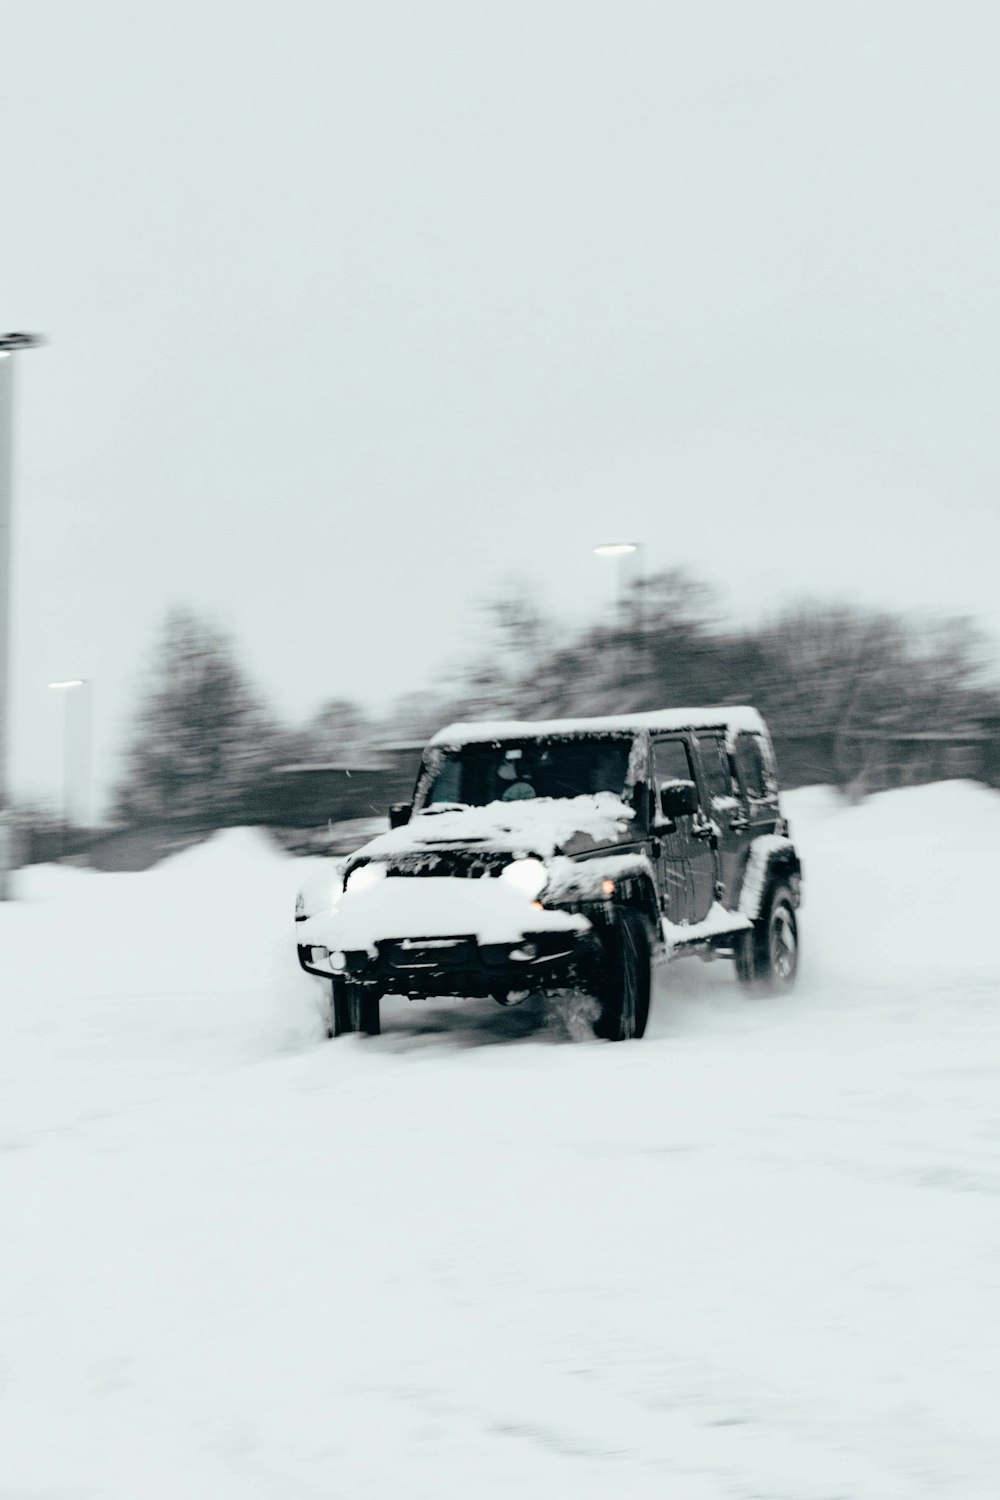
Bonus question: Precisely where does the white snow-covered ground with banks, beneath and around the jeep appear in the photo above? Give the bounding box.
[0,783,1000,1500]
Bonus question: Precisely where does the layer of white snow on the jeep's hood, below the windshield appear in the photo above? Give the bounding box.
[358,792,634,860]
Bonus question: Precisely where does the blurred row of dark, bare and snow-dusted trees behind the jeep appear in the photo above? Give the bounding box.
[29,570,1000,827]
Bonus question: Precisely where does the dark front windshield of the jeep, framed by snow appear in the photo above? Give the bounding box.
[414,735,631,812]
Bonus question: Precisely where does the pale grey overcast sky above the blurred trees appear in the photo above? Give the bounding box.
[0,0,1000,822]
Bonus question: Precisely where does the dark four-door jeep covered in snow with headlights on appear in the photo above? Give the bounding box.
[295,707,802,1041]
